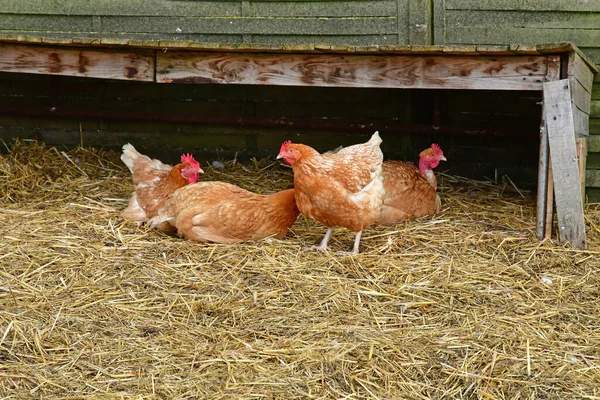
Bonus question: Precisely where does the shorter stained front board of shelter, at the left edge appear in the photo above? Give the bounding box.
[0,44,154,81]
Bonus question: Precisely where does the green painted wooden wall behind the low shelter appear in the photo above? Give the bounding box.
[0,0,600,201]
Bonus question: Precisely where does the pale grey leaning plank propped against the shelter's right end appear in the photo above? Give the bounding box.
[543,79,586,248]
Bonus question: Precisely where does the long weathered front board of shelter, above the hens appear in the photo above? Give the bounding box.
[156,51,547,90]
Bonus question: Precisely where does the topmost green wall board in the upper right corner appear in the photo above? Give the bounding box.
[446,0,600,12]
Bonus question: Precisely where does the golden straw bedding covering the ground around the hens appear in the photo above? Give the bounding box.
[0,139,600,399]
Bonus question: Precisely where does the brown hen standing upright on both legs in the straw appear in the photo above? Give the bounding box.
[277,132,384,254]
